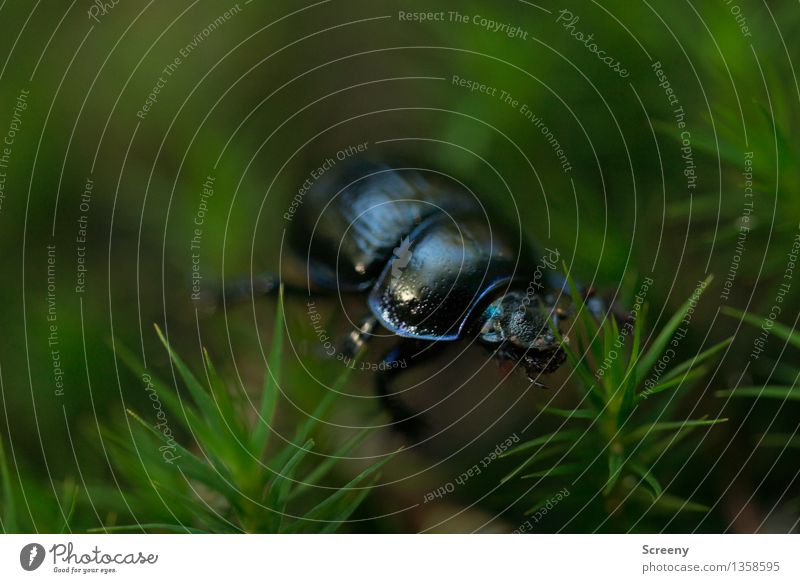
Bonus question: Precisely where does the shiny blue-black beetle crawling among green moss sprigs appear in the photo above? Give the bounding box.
[223,159,580,436]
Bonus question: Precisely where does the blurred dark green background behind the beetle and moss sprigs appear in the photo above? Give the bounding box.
[0,0,800,532]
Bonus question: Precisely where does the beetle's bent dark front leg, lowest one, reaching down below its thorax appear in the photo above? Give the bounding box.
[376,340,442,441]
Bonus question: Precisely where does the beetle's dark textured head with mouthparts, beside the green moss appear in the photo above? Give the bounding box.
[479,291,566,382]
